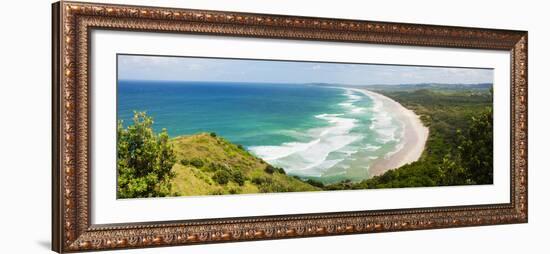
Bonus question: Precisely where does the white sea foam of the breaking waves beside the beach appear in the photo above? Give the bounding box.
[253,88,402,177]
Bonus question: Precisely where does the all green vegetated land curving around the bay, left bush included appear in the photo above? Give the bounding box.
[117,84,493,198]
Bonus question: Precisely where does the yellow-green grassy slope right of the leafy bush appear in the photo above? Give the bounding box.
[170,133,319,196]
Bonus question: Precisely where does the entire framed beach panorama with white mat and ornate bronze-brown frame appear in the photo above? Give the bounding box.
[52,2,527,252]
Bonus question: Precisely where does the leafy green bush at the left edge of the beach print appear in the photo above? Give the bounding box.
[117,112,176,198]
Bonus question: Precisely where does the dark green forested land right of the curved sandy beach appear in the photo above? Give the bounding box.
[324,87,493,190]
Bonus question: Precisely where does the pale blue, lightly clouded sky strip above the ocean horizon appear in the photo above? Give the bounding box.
[118,55,493,85]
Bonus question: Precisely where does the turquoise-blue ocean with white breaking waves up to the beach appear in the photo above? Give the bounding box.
[117,80,403,183]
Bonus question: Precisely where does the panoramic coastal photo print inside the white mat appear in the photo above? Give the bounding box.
[116,54,494,198]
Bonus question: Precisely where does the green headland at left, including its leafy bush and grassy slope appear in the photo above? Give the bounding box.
[117,112,321,198]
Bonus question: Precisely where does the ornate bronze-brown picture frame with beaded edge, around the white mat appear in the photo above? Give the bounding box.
[52,2,527,252]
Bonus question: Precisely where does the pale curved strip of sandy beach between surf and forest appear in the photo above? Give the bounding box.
[353,89,429,177]
